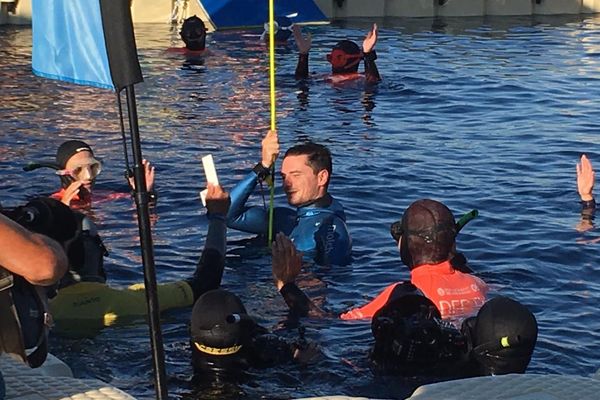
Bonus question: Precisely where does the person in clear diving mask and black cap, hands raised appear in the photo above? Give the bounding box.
[50,140,156,208]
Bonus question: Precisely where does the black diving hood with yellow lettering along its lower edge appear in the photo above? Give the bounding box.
[190,289,249,356]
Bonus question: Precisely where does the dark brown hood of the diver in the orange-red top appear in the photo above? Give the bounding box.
[400,199,456,269]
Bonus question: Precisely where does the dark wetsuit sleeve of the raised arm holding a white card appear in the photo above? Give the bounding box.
[188,215,227,299]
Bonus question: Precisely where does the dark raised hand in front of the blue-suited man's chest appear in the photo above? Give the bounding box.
[272,233,302,290]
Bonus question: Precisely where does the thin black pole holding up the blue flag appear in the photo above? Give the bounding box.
[125,85,168,400]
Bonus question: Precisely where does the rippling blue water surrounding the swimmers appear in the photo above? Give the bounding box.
[0,16,600,398]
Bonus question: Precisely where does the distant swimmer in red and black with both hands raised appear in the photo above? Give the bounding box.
[292,24,381,83]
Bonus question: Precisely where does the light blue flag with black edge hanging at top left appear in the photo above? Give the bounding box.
[32,0,143,91]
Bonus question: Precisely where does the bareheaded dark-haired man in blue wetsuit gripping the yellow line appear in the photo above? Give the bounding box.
[227,131,352,265]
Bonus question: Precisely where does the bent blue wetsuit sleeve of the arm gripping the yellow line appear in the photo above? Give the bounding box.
[227,171,268,234]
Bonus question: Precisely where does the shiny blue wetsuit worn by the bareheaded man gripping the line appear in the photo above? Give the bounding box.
[227,172,352,265]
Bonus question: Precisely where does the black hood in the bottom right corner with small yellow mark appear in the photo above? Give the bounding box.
[472,296,538,375]
